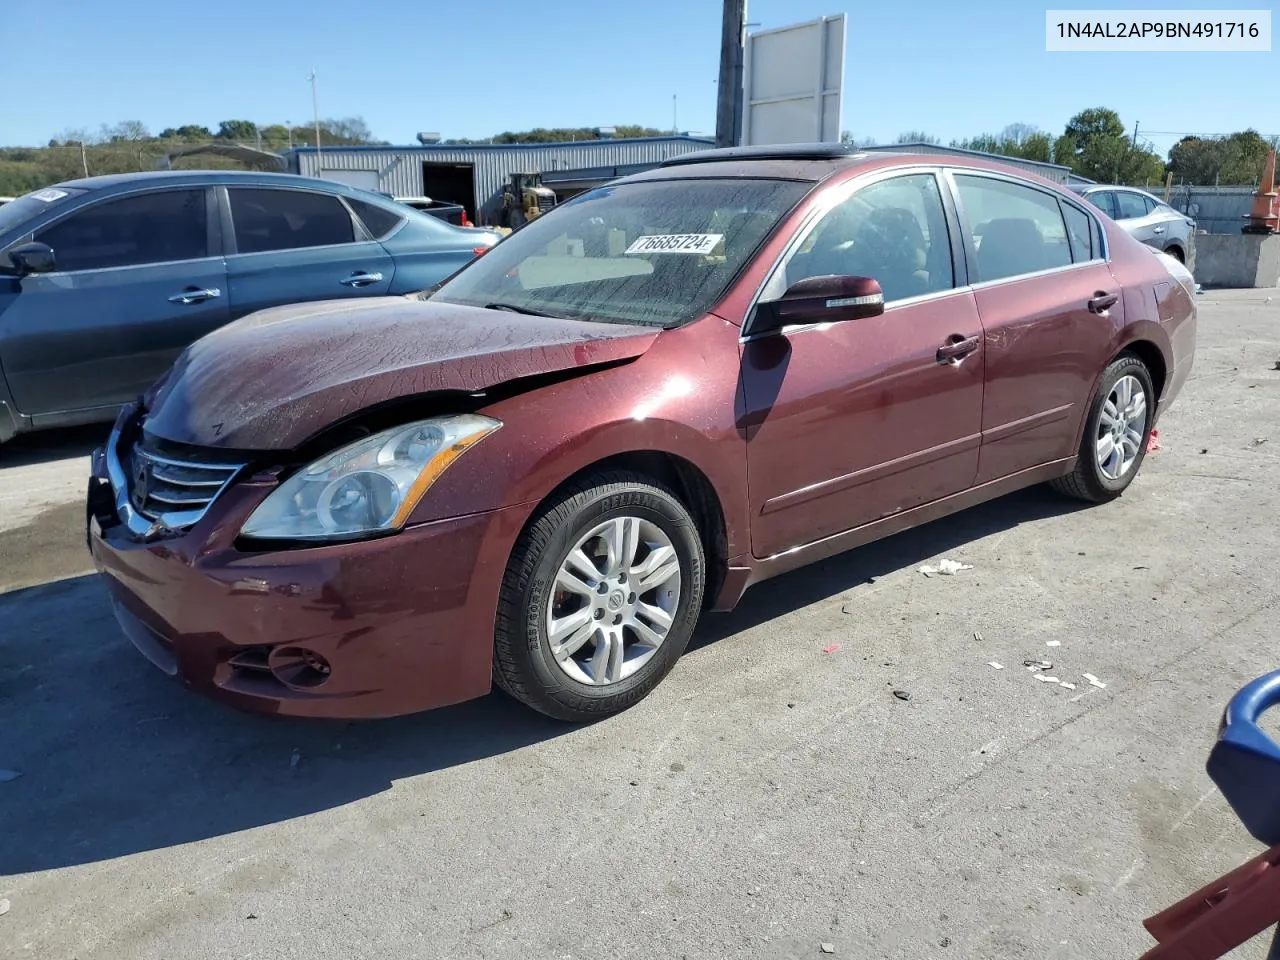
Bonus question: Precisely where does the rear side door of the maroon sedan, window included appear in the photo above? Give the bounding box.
[948,172,1123,483]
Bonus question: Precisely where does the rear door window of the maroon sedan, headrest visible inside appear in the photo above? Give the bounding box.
[955,174,1071,282]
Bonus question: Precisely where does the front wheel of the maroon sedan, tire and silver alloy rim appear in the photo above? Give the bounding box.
[493,471,705,722]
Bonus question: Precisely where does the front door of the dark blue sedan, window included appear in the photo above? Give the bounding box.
[0,187,229,416]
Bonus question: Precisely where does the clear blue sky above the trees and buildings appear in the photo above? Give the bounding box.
[0,0,1280,158]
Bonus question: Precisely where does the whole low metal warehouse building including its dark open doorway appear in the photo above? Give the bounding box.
[284,136,714,223]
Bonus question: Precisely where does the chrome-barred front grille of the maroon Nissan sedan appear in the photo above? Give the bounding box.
[125,440,243,530]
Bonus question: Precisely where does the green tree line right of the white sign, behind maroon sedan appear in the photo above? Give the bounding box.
[844,106,1277,187]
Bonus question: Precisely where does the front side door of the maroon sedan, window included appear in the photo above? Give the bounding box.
[741,172,983,557]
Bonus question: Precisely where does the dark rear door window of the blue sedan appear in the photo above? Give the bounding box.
[228,187,356,253]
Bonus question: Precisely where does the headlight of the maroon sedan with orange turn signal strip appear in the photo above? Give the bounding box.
[241,413,502,540]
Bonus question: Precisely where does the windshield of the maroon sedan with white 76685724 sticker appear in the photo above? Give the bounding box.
[431,179,812,326]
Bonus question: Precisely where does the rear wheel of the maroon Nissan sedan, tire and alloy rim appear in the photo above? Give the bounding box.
[1050,353,1156,503]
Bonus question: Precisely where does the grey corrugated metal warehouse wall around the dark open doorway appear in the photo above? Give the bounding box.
[288,137,714,224]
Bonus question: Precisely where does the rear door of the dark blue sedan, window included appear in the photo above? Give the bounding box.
[227,180,396,317]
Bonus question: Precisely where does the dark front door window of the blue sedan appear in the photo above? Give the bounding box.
[35,188,209,271]
